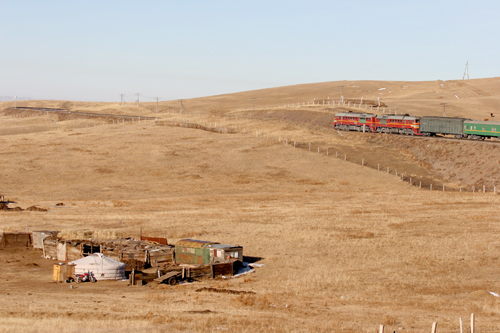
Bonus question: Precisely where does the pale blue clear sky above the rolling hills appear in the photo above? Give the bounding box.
[0,0,500,102]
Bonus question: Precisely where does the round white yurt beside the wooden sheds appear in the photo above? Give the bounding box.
[71,253,126,281]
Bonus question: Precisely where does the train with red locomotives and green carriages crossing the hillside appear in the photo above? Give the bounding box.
[333,111,500,140]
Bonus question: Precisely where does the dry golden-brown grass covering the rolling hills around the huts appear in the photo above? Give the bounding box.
[0,78,500,333]
